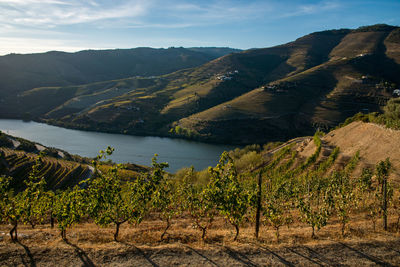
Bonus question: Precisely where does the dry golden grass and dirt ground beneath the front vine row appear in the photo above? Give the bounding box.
[0,220,400,267]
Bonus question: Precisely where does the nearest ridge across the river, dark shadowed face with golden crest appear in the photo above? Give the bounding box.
[178,26,400,142]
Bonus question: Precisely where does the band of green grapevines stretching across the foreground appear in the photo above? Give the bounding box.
[0,133,400,241]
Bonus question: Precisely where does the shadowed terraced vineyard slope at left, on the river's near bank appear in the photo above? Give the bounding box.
[0,132,147,191]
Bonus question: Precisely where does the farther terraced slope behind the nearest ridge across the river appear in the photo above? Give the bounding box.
[21,30,347,128]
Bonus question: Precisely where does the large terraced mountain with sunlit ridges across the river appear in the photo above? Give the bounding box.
[0,25,400,144]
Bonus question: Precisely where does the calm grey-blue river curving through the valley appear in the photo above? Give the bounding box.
[0,119,234,172]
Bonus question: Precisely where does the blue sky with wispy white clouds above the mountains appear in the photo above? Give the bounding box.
[0,0,400,55]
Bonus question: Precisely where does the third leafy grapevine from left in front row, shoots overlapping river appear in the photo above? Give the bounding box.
[87,147,168,241]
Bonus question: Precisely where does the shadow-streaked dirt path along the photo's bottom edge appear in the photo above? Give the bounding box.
[0,240,400,267]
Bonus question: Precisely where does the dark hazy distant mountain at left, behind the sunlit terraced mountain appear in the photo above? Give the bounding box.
[0,47,240,100]
